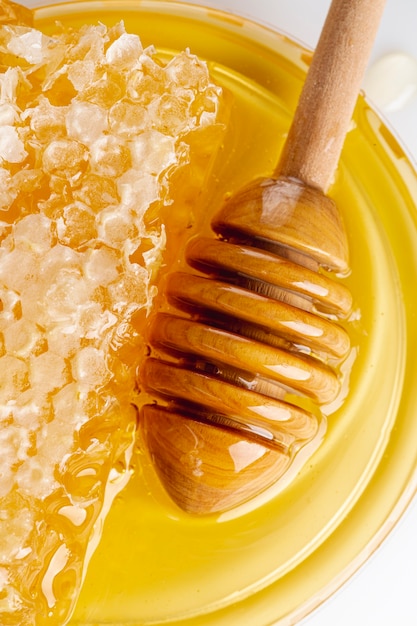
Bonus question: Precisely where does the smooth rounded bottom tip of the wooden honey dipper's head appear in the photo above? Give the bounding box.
[143,405,290,514]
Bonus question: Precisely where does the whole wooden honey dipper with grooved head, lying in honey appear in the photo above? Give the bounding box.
[139,0,385,514]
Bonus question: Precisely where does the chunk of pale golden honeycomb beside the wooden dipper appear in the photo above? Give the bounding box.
[0,2,222,626]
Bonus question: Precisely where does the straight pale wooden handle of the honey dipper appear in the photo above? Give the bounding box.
[277,0,385,192]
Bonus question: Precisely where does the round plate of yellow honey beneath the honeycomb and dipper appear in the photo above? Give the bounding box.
[35,0,417,626]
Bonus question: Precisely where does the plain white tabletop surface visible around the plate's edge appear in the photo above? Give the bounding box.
[22,0,417,626]
